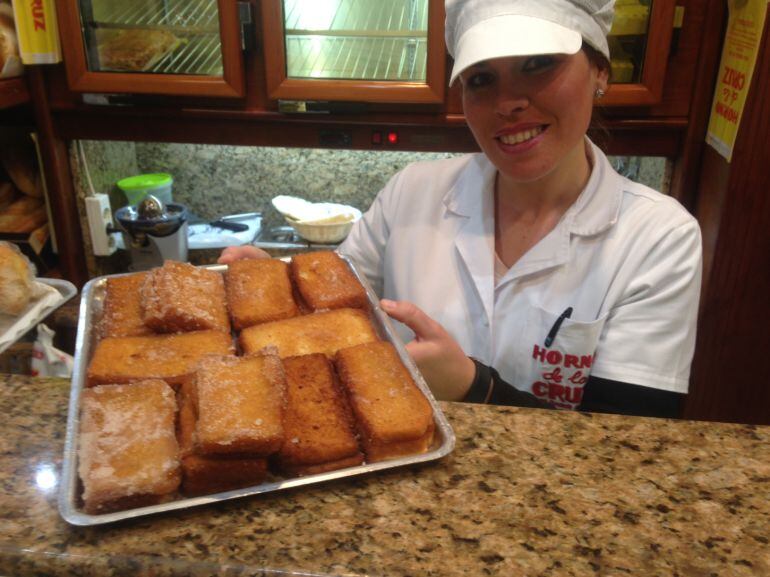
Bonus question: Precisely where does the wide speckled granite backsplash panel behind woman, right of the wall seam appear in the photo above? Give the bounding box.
[130,143,668,226]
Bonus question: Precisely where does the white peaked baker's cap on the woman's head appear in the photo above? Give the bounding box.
[446,0,615,84]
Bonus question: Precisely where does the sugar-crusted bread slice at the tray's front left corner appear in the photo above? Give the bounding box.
[78,379,181,514]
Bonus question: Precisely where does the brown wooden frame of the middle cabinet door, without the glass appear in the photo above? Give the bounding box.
[261,0,447,104]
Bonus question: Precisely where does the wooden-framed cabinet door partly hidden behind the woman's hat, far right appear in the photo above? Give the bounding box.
[602,0,675,106]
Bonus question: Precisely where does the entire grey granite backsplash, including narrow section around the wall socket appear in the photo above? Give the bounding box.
[70,141,671,276]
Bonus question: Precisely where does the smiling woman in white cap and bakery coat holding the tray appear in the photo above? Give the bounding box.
[221,0,701,416]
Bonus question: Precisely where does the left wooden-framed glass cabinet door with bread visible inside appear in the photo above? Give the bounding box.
[57,0,244,97]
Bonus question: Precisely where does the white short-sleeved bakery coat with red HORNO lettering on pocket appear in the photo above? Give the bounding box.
[340,141,702,408]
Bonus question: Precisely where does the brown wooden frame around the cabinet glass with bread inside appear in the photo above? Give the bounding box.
[56,0,245,98]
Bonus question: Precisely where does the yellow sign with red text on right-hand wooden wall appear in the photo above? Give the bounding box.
[706,0,768,162]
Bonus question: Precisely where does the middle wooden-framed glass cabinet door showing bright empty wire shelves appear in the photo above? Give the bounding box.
[262,0,446,103]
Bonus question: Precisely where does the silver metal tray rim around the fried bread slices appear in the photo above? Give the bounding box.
[59,255,455,526]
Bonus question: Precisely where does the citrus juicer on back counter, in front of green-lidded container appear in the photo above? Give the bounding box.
[115,195,188,271]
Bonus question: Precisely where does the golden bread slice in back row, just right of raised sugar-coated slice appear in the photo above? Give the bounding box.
[225,258,300,330]
